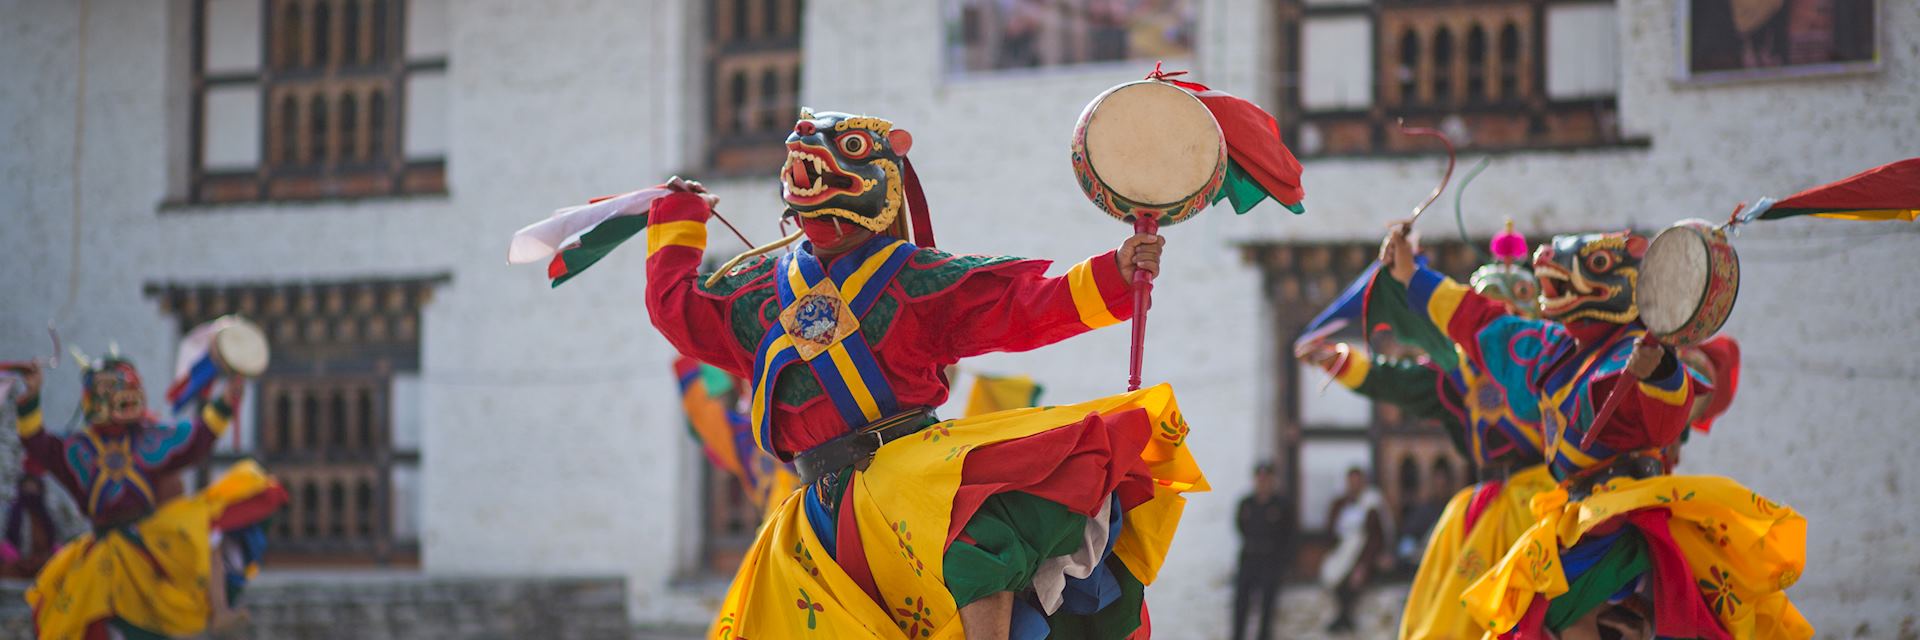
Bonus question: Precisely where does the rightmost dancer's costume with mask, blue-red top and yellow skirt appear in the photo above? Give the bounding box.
[1407,234,1812,638]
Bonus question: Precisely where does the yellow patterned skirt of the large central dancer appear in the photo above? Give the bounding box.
[708,384,1208,640]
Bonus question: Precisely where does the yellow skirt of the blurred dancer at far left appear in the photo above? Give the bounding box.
[27,461,275,640]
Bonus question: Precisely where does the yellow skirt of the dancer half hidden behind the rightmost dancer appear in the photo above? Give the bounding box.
[1400,465,1555,640]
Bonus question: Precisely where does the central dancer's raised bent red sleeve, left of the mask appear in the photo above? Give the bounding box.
[647,194,753,377]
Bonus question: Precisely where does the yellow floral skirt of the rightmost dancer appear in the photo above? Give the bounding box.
[1461,475,1812,640]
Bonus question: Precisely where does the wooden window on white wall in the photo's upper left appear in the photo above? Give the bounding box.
[186,0,447,202]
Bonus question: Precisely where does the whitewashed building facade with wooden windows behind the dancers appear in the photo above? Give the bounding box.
[0,0,1920,636]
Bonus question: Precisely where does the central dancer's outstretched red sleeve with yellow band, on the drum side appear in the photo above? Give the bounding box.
[916,252,1133,359]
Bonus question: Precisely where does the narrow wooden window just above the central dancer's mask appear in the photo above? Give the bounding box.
[707,0,801,175]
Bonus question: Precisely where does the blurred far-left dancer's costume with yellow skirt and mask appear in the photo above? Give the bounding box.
[17,359,286,640]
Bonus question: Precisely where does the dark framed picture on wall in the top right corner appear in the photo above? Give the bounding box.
[1678,0,1880,83]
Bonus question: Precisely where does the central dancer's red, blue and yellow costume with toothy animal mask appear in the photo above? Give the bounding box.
[647,107,1206,640]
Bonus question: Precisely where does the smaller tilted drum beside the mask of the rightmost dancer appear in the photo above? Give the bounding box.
[1634,219,1740,346]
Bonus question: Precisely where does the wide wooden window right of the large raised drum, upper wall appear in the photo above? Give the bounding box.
[1275,0,1644,156]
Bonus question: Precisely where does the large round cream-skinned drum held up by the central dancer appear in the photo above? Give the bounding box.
[1073,81,1227,225]
